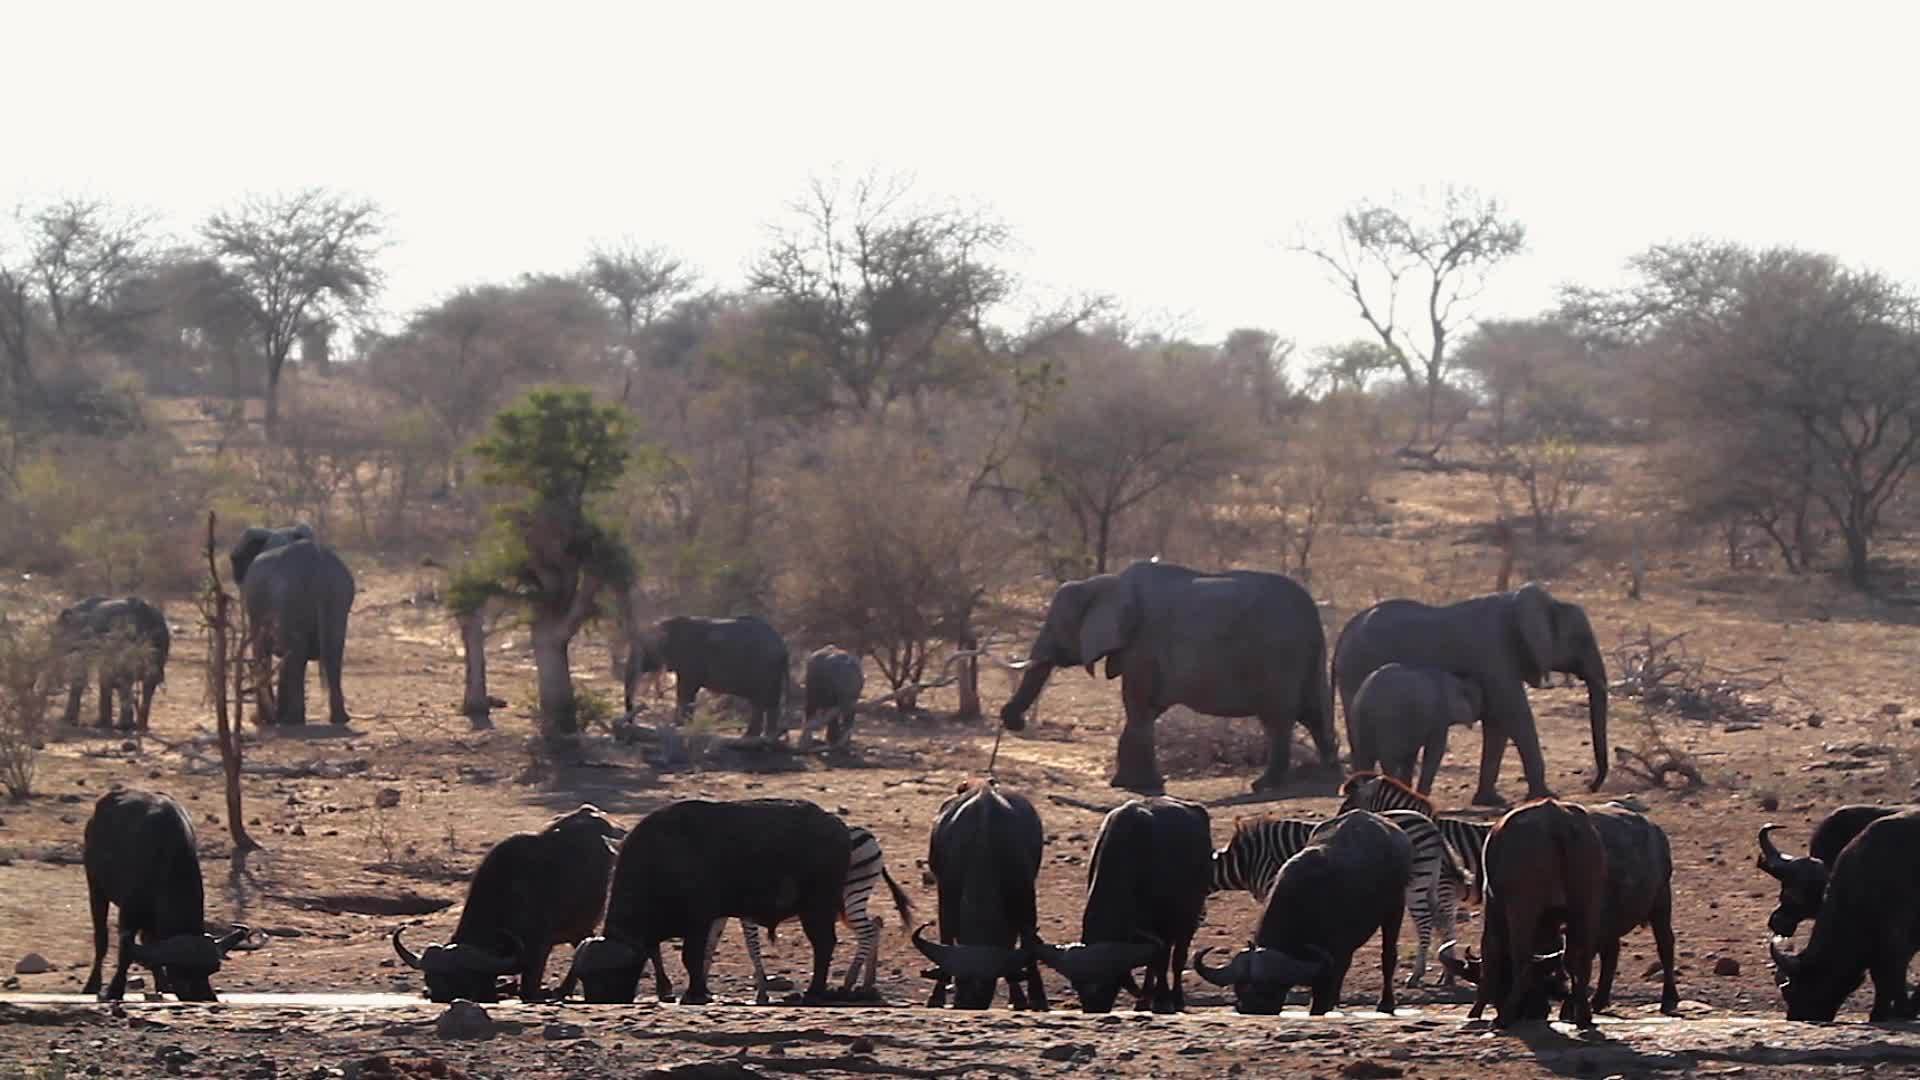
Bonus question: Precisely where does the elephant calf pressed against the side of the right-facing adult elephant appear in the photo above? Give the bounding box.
[1346,663,1486,796]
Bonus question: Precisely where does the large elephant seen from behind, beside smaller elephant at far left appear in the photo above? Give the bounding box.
[228,525,353,724]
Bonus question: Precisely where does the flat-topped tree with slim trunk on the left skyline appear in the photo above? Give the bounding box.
[200,188,380,440]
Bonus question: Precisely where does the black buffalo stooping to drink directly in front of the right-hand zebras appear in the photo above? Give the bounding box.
[1194,811,1413,1015]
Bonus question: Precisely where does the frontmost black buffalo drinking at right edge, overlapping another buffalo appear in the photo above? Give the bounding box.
[1768,809,1920,1020]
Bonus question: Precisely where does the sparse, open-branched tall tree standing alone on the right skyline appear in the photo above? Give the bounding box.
[1294,186,1526,442]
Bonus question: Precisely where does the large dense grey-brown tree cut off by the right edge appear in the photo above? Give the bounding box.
[1567,244,1920,588]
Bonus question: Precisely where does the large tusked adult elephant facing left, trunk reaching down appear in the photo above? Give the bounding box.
[1000,561,1336,794]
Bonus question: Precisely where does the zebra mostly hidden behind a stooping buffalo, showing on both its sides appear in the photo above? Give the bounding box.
[1212,807,1459,986]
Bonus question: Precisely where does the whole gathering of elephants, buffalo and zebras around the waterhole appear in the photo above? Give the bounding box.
[45,527,1920,1026]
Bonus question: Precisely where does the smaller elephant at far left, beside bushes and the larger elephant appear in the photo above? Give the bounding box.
[56,596,173,730]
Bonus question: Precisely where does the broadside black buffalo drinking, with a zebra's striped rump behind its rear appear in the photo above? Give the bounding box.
[561,799,852,1005]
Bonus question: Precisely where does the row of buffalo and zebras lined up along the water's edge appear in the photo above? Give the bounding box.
[84,773,1920,1026]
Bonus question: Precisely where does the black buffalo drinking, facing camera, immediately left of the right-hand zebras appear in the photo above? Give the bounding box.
[1039,798,1213,1013]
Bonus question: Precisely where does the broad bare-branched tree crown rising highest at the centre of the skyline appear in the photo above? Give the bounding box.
[747,179,1012,413]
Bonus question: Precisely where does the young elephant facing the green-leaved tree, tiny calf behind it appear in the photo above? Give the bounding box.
[626,615,787,738]
